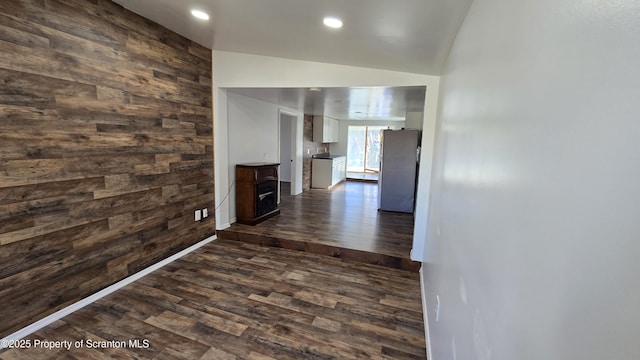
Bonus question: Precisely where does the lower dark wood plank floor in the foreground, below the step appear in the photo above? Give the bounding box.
[0,239,425,360]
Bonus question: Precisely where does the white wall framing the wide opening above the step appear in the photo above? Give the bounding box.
[213,50,440,260]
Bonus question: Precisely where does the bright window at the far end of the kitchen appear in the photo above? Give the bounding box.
[347,126,389,173]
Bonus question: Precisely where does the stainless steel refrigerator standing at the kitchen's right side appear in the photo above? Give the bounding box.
[378,130,420,213]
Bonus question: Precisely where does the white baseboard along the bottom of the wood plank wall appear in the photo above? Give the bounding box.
[0,235,217,350]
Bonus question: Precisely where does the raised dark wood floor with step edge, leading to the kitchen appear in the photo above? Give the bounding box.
[218,181,420,271]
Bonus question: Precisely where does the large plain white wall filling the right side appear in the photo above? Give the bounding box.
[423,0,640,360]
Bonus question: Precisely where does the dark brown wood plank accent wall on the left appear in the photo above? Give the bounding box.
[0,0,215,337]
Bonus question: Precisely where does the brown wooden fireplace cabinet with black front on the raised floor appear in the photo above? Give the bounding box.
[236,163,280,225]
